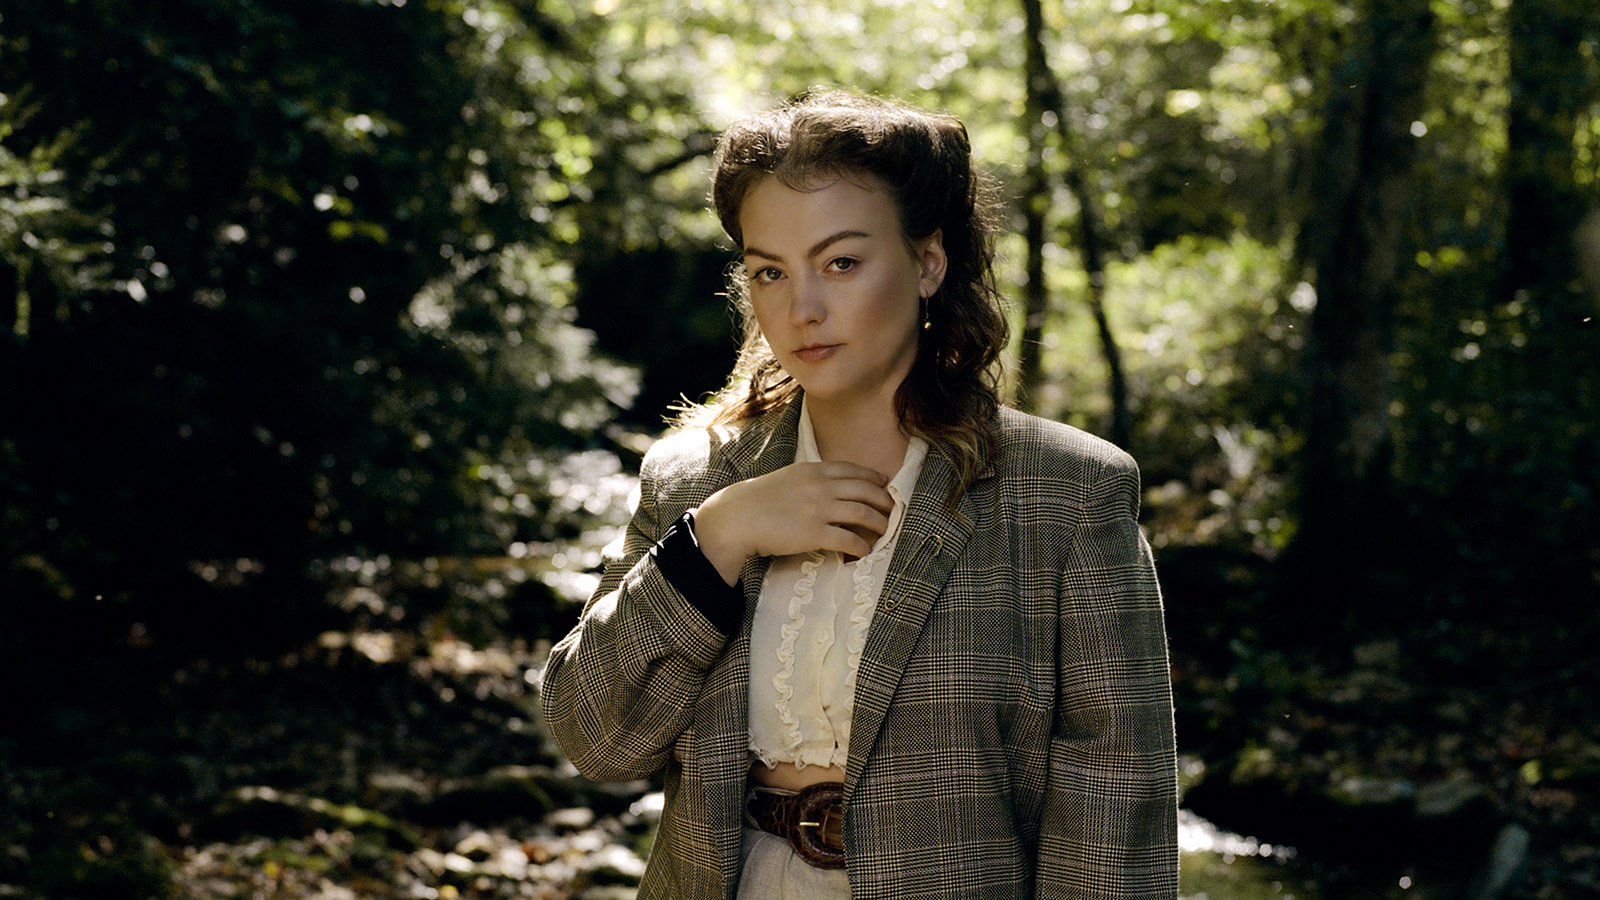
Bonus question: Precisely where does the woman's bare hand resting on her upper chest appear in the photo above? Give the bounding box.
[694,461,894,585]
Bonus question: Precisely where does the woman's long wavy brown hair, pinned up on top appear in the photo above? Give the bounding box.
[678,91,1008,501]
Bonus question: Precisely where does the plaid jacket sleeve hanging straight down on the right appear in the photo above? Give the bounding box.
[1035,452,1178,900]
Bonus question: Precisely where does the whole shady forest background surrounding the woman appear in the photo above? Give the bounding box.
[0,0,1600,897]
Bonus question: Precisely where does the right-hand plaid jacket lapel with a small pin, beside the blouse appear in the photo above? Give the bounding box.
[845,448,978,798]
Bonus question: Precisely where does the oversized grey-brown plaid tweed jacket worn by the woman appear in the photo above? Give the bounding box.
[541,402,1178,900]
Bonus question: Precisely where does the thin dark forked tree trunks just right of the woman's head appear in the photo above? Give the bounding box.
[1021,0,1133,447]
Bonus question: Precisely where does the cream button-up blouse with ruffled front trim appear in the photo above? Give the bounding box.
[750,400,928,769]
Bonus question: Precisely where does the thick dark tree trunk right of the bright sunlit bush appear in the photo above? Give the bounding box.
[1294,0,1435,609]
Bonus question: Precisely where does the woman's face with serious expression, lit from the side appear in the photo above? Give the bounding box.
[739,176,946,405]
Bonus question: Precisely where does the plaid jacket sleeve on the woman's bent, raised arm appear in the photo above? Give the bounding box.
[539,445,728,781]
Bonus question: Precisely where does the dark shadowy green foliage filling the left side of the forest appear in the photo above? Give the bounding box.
[0,0,652,646]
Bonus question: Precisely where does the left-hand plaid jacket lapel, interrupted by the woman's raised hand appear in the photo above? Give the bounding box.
[694,399,800,884]
